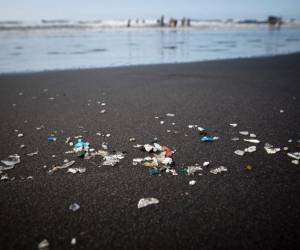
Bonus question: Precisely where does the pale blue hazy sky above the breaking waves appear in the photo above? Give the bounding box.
[0,0,300,20]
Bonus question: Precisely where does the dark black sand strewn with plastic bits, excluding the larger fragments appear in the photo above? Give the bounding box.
[0,54,300,249]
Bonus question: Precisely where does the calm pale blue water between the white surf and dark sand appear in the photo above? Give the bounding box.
[0,26,300,73]
